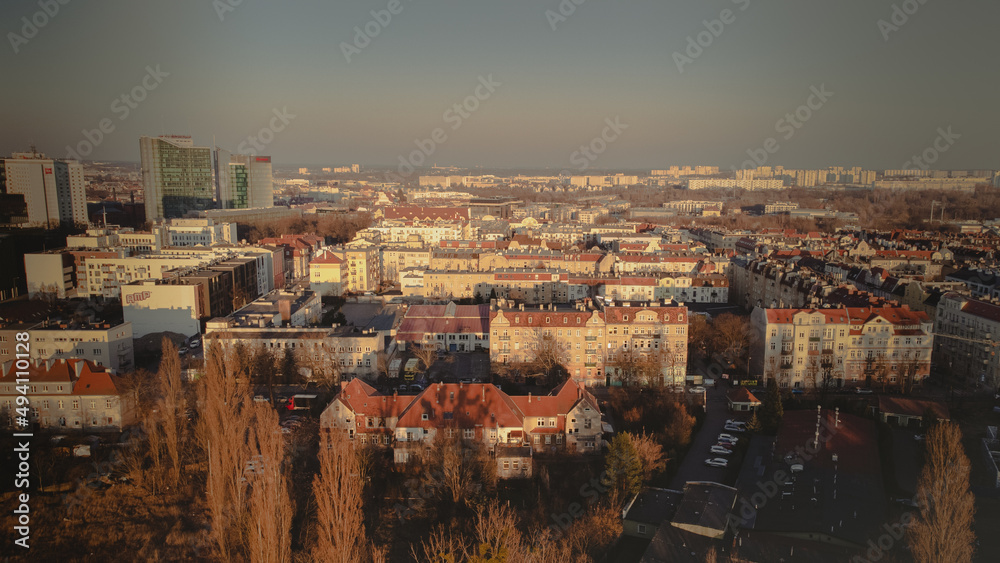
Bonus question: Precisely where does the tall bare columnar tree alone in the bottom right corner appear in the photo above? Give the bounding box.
[907,423,976,563]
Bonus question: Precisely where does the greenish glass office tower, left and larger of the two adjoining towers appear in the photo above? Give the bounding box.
[139,135,215,221]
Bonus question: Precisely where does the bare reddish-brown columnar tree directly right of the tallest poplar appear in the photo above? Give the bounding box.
[244,405,295,563]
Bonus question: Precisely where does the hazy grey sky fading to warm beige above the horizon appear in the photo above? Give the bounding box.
[0,0,1000,170]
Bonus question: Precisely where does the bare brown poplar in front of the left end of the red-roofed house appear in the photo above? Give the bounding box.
[312,430,365,563]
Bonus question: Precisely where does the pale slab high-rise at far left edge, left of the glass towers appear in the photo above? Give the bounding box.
[0,150,87,226]
